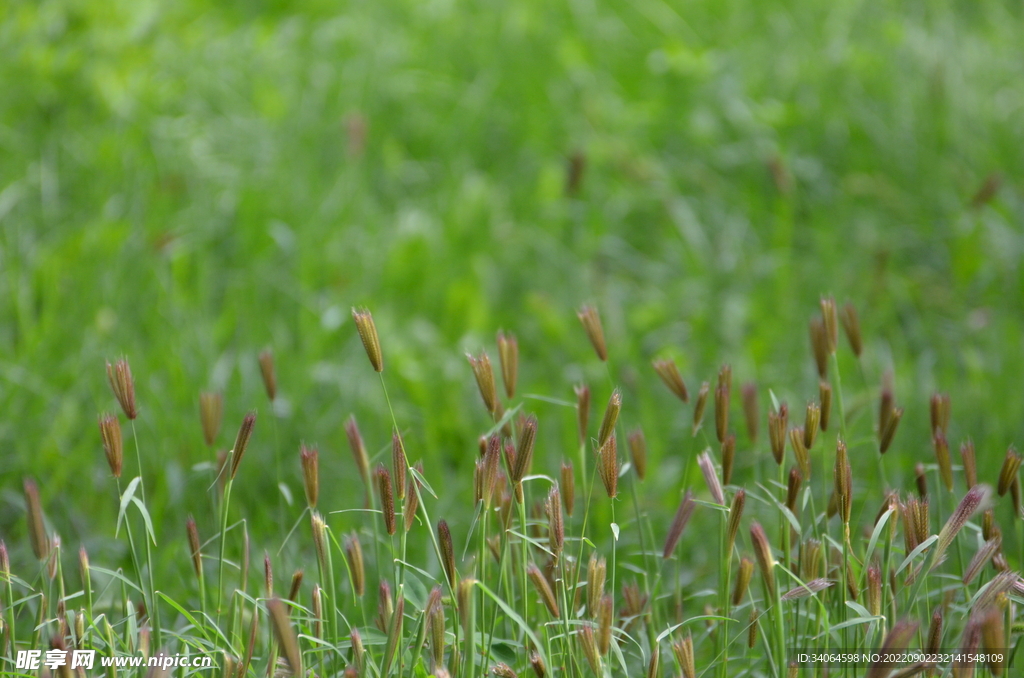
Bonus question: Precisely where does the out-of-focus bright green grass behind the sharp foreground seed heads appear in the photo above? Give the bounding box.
[0,0,1024,576]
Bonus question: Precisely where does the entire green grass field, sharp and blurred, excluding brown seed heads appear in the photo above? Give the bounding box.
[0,0,1024,676]
